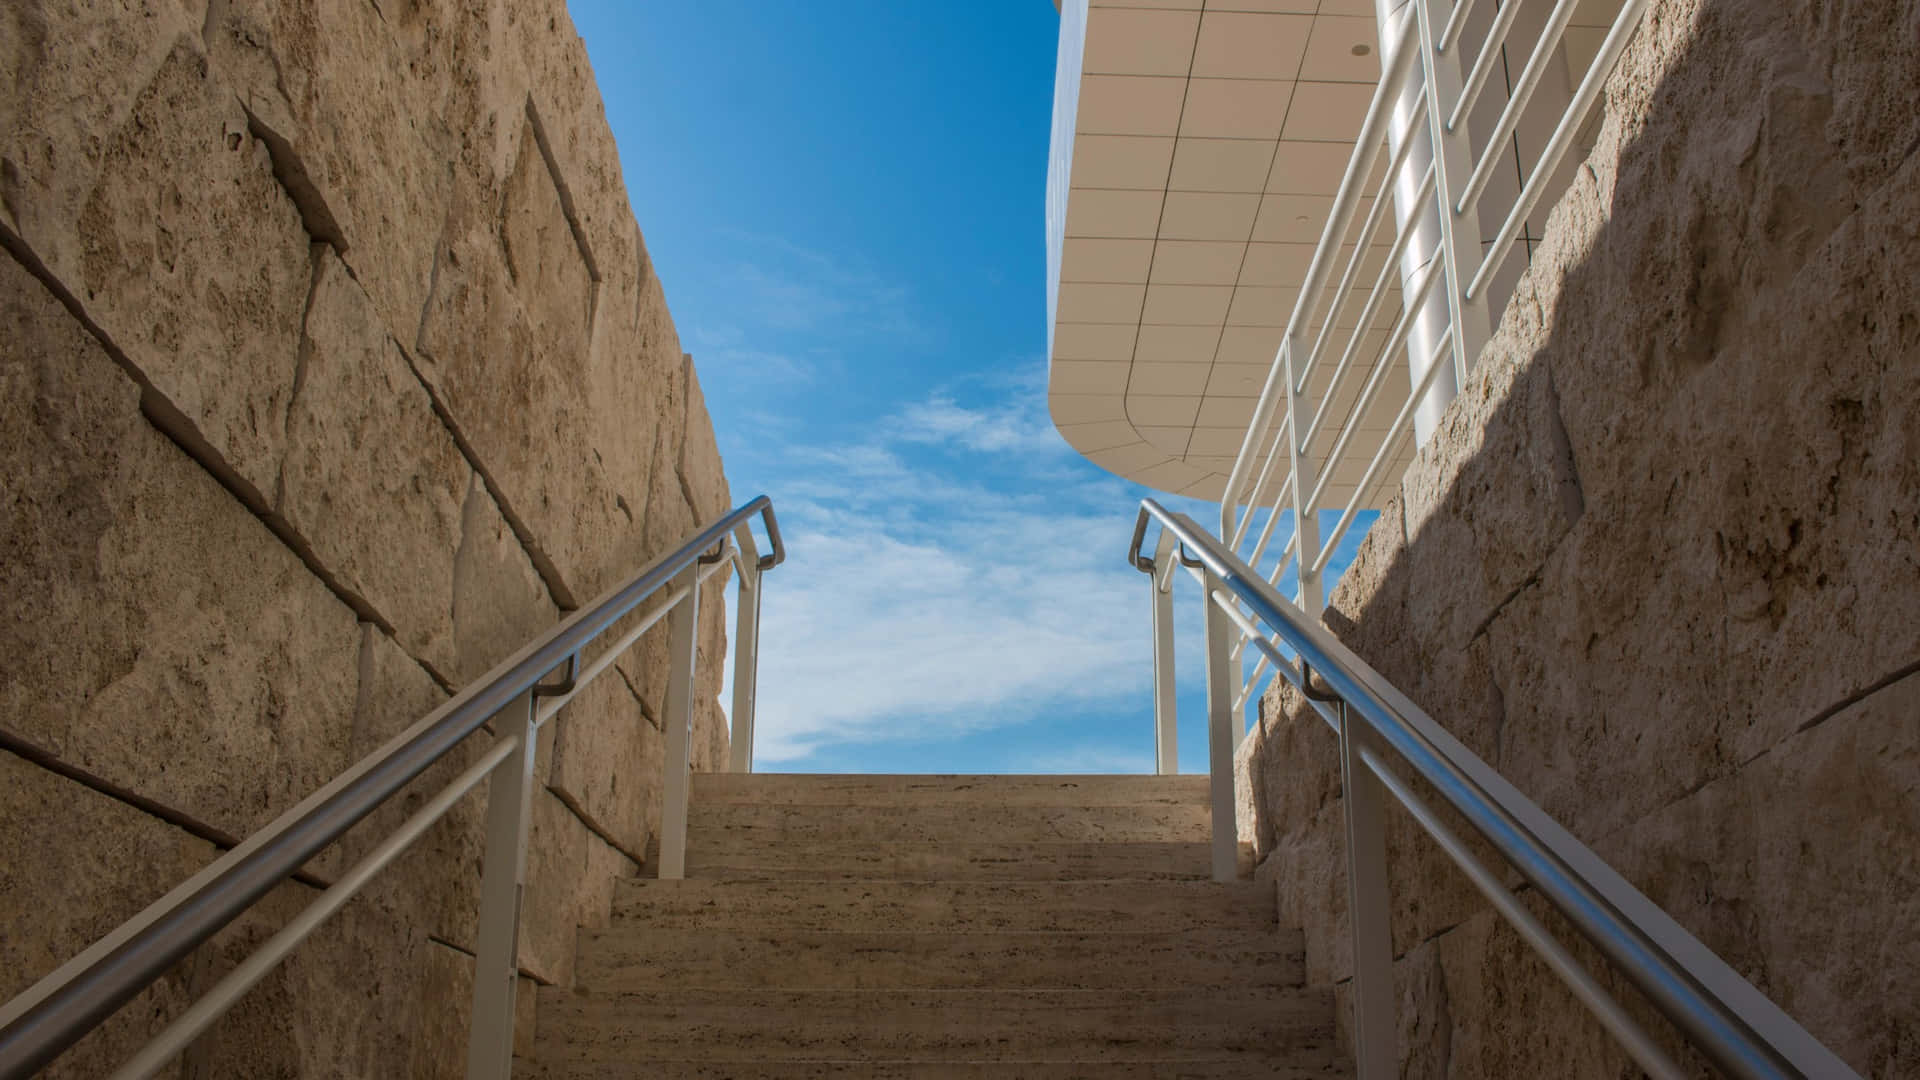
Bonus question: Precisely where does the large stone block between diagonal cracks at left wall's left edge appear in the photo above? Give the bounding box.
[0,251,359,836]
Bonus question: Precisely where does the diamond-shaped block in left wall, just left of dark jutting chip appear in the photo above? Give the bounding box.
[57,40,313,502]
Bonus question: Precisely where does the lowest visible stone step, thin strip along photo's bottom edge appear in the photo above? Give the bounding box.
[513,1055,1354,1080]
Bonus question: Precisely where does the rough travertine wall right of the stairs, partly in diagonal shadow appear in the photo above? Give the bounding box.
[1240,0,1920,1076]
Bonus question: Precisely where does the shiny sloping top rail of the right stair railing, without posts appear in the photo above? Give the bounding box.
[1140,500,1855,1078]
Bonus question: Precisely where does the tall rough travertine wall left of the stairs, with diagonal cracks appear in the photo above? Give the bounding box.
[0,0,730,1076]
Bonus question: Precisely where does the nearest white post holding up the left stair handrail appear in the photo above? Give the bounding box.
[467,690,538,1080]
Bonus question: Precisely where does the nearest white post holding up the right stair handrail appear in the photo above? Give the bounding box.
[1338,701,1400,1080]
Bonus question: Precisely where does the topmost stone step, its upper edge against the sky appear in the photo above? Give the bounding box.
[691,773,1208,803]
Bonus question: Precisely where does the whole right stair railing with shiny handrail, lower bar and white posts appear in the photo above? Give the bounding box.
[1127,500,1859,1080]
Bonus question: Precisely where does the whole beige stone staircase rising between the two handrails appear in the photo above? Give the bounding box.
[522,774,1350,1080]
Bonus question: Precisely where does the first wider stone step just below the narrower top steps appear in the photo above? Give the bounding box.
[612,878,1277,934]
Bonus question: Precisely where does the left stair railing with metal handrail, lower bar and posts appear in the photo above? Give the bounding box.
[0,496,785,1080]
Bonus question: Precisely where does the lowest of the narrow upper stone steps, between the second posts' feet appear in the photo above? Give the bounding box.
[687,828,1212,882]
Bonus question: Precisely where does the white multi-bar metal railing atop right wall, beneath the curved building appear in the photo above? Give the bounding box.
[1219,0,1647,726]
